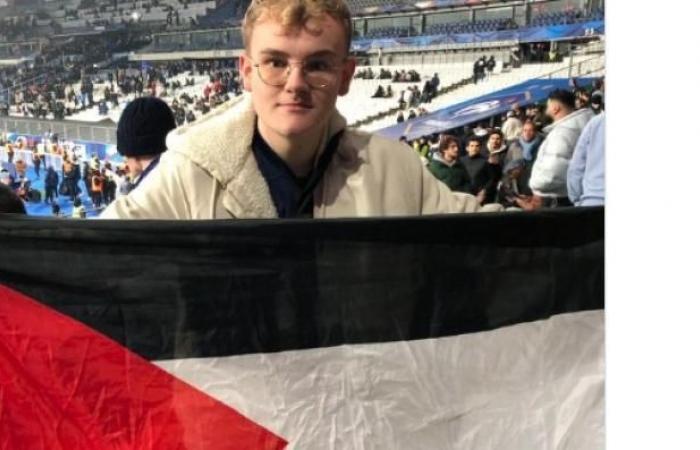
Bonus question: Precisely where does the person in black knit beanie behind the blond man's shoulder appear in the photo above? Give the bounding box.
[117,97,177,189]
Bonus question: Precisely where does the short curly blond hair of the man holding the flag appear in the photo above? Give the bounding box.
[243,0,352,52]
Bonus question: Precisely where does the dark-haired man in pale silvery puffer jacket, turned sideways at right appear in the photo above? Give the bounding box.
[518,90,593,209]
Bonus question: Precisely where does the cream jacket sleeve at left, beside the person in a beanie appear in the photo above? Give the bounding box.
[99,152,195,219]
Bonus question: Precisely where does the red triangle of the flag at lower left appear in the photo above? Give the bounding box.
[0,285,287,450]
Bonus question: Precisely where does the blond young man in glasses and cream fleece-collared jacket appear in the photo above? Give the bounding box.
[102,0,500,219]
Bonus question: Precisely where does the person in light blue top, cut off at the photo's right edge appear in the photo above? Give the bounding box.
[566,113,605,206]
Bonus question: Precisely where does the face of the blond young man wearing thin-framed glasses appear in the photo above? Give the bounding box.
[240,15,355,138]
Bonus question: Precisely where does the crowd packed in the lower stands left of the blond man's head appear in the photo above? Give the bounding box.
[0,55,242,125]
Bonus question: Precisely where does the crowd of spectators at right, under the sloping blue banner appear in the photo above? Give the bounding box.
[416,79,605,210]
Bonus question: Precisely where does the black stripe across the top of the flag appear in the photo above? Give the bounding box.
[0,208,604,359]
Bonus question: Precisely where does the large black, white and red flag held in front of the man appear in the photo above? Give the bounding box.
[0,208,604,450]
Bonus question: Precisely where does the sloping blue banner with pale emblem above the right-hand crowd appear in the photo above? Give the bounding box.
[377,78,593,140]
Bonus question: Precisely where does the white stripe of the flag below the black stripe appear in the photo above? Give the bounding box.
[157,311,604,450]
